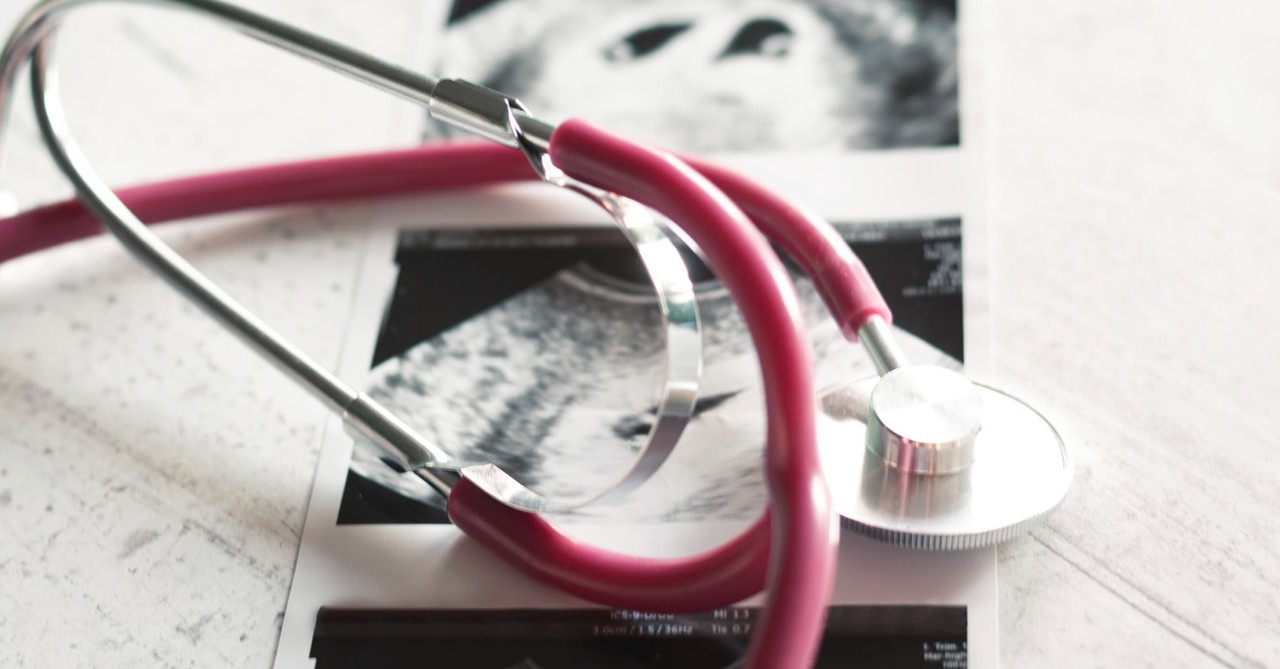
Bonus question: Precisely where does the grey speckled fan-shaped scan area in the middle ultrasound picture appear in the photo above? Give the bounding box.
[352,267,959,522]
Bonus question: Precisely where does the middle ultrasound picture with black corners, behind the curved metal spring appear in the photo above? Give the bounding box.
[338,219,964,524]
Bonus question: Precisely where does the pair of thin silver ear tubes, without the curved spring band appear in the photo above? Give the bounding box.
[0,0,476,466]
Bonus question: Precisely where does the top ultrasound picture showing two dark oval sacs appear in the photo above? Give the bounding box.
[433,0,960,152]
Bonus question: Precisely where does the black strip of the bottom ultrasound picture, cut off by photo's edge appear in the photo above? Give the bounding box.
[311,605,968,669]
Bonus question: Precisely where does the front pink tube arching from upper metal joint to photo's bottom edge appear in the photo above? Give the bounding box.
[552,122,840,668]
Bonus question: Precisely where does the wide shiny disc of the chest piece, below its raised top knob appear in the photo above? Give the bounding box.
[818,367,1071,550]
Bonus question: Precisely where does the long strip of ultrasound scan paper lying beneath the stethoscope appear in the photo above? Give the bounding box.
[275,0,998,669]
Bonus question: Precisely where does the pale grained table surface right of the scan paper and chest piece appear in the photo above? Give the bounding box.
[988,3,1280,668]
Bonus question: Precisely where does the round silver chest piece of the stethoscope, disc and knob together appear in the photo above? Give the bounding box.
[818,366,1071,550]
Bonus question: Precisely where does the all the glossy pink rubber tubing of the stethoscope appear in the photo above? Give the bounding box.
[0,122,888,668]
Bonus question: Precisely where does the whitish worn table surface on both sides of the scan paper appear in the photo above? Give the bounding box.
[0,0,1280,668]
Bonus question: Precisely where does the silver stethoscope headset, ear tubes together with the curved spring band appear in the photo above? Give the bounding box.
[10,0,701,510]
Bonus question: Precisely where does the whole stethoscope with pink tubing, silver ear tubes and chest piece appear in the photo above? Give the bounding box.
[0,0,1071,668]
